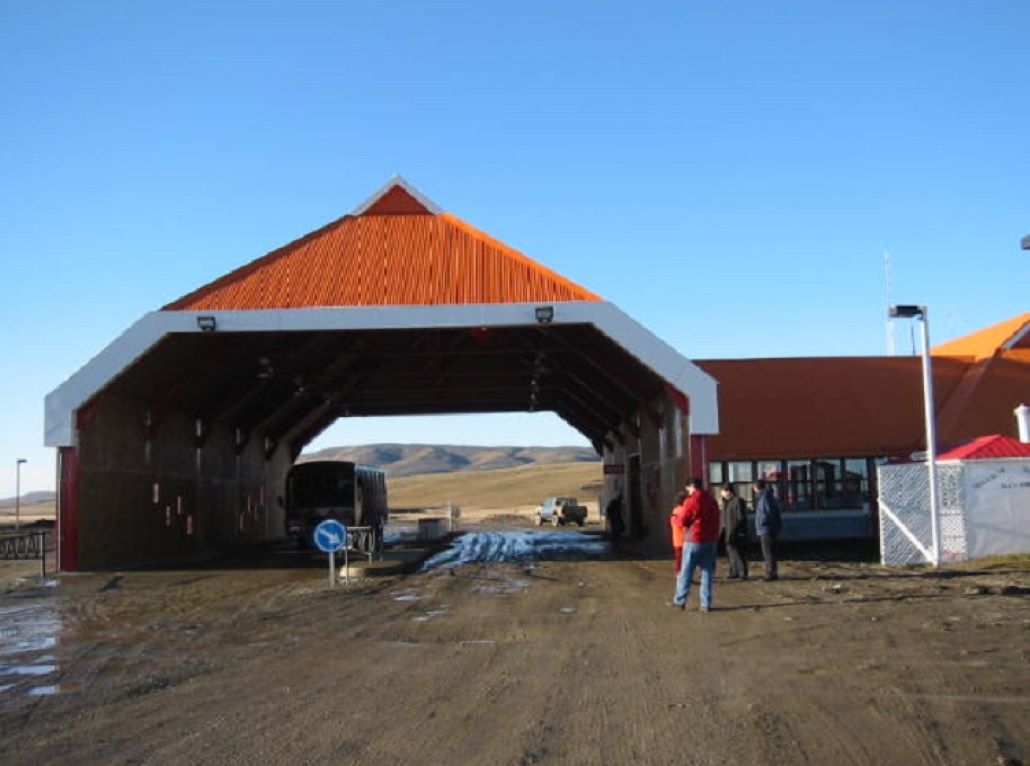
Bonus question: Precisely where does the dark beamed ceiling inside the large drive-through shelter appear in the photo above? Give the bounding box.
[96,324,665,456]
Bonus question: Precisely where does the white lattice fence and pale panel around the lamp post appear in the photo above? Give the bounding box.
[878,459,1030,566]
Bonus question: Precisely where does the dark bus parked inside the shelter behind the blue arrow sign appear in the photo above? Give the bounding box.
[286,460,388,552]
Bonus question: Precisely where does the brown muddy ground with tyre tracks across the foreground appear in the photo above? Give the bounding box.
[0,531,1030,766]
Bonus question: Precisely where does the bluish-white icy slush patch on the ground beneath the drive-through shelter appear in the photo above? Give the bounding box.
[421,530,611,571]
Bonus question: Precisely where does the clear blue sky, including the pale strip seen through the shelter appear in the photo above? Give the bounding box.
[0,0,1030,497]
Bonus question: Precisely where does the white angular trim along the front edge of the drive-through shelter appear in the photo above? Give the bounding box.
[44,301,719,447]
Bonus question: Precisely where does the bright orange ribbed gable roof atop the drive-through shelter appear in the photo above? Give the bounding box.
[164,183,600,310]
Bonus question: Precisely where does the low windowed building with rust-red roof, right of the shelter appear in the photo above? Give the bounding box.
[697,313,1030,539]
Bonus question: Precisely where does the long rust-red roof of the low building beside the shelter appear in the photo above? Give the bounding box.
[697,336,1030,460]
